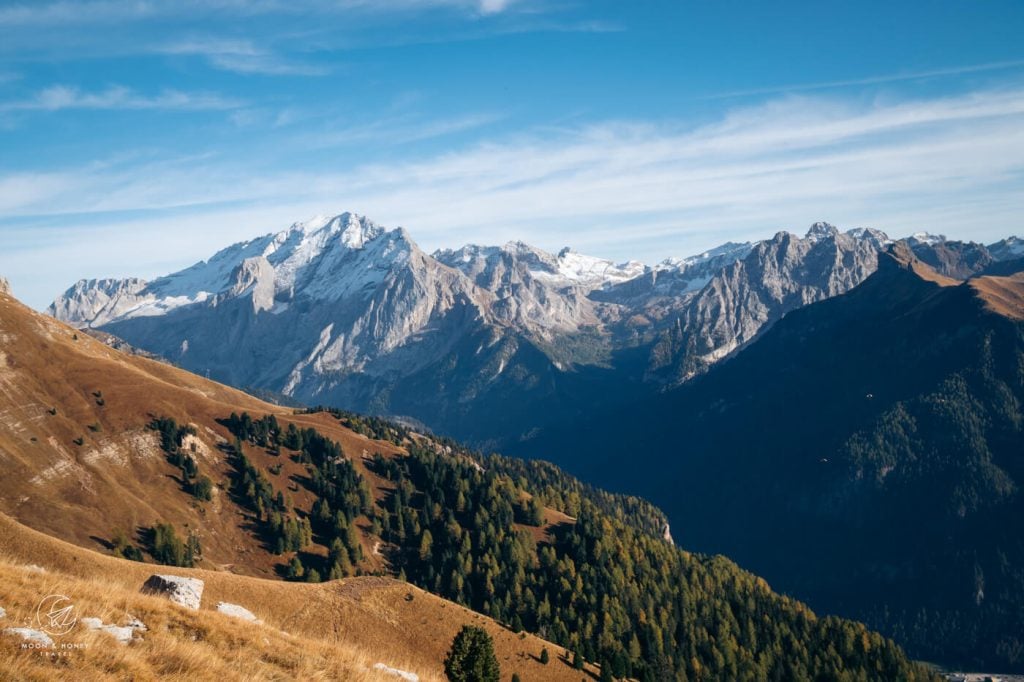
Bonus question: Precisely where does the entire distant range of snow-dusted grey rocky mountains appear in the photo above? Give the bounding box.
[49,213,1024,445]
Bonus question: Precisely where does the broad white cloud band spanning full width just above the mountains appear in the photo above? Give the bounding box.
[0,84,1024,305]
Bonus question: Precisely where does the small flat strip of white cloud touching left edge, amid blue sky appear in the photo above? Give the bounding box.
[0,85,242,112]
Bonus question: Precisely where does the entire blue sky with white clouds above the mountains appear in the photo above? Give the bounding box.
[0,0,1024,307]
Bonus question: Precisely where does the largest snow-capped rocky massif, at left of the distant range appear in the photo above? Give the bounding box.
[50,214,493,401]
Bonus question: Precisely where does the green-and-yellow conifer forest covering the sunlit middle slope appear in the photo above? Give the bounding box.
[226,405,930,680]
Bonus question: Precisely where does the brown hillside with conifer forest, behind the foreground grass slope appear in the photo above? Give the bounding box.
[0,278,931,680]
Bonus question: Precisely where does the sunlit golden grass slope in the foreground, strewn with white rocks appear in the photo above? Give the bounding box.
[0,501,594,680]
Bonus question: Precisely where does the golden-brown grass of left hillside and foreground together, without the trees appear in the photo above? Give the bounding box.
[0,293,593,680]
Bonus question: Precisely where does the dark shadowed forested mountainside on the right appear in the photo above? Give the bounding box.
[522,246,1024,671]
